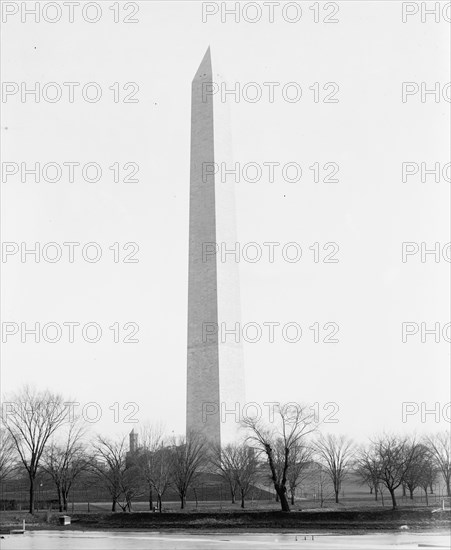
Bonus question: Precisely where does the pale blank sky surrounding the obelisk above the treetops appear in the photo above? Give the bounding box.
[2,1,450,439]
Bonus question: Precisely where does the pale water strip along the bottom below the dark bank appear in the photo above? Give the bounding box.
[0,531,450,550]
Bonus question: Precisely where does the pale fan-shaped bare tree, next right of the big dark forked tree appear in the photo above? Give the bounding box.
[315,434,354,504]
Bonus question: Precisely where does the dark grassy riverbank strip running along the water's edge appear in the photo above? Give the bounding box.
[0,510,451,534]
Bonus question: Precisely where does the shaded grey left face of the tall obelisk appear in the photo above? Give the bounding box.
[187,50,220,443]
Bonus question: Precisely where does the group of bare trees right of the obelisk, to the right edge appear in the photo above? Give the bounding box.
[244,406,451,511]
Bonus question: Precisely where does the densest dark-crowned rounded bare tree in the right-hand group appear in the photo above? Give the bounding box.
[372,435,416,509]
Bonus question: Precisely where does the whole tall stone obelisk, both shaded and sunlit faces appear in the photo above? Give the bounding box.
[186,48,244,444]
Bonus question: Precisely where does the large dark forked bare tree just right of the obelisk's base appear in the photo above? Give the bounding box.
[243,404,315,512]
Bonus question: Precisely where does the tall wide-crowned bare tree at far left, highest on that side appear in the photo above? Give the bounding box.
[2,386,70,514]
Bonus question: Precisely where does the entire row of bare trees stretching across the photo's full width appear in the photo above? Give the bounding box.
[0,387,451,513]
